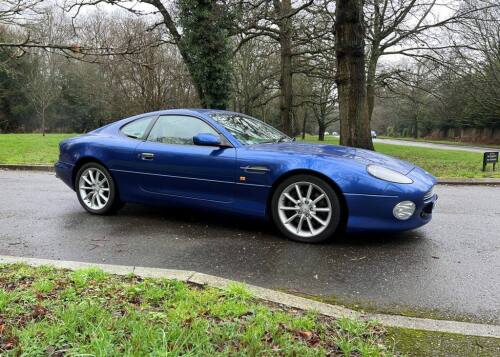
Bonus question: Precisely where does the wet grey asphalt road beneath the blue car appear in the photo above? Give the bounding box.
[0,171,500,323]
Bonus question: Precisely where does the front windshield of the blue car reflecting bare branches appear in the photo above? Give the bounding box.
[210,113,292,145]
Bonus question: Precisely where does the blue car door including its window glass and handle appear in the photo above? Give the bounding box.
[137,115,236,203]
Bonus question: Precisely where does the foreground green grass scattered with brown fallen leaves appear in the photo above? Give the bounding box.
[0,264,394,357]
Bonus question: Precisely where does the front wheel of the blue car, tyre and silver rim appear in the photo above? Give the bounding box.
[271,174,342,243]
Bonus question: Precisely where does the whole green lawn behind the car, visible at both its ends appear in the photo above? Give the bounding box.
[0,134,500,178]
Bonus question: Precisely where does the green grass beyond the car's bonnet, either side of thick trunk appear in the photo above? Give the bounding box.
[300,136,500,178]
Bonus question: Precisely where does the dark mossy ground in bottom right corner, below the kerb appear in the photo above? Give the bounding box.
[385,327,500,357]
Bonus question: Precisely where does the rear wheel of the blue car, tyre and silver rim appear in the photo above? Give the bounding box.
[75,162,122,215]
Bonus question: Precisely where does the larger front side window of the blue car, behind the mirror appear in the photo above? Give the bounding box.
[148,115,219,145]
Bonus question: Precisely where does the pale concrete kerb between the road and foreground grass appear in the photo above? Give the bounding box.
[0,256,500,338]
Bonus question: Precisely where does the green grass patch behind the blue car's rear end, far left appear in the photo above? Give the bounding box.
[0,134,77,164]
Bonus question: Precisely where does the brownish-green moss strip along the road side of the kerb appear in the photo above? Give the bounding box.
[279,289,498,324]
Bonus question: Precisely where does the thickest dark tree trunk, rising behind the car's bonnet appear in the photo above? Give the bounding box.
[335,0,373,150]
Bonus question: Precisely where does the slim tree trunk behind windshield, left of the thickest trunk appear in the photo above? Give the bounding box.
[279,0,293,136]
